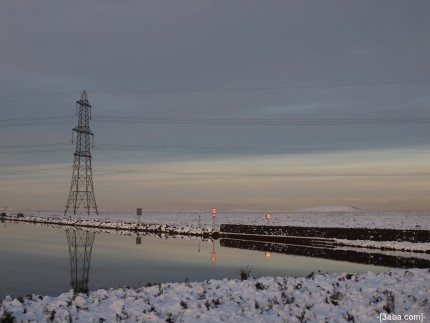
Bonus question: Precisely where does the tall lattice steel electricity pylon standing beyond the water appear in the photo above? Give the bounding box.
[64,91,99,215]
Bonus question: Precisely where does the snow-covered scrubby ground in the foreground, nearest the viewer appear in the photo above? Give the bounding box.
[0,269,430,322]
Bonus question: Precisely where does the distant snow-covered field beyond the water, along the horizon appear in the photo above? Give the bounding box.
[9,206,430,231]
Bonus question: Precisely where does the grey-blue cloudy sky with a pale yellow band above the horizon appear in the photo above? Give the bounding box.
[0,0,430,212]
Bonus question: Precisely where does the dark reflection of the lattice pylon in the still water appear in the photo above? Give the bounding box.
[66,229,96,293]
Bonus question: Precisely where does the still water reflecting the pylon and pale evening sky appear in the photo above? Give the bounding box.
[0,222,394,299]
